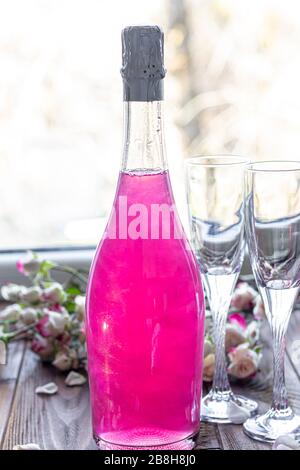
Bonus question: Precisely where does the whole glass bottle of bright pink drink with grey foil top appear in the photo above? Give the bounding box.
[86,26,204,449]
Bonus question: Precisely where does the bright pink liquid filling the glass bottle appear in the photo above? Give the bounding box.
[86,172,204,449]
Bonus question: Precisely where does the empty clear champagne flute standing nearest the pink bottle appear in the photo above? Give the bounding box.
[186,156,257,423]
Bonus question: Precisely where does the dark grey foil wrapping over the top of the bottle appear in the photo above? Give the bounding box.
[121,26,166,101]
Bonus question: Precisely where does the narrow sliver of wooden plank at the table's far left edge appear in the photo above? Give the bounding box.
[0,341,26,448]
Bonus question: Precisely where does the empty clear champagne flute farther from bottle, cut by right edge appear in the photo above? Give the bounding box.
[244,161,300,442]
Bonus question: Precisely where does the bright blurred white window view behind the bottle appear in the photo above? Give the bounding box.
[0,0,300,250]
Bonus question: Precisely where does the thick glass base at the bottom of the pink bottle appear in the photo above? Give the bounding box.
[94,428,198,450]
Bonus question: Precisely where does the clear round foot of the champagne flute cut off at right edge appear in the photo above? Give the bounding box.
[244,408,300,442]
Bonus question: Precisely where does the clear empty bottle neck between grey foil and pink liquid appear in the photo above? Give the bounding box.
[122,101,167,173]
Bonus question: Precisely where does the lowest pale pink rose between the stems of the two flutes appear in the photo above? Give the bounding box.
[228,343,260,379]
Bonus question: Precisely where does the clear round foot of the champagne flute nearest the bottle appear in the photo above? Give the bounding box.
[201,391,258,424]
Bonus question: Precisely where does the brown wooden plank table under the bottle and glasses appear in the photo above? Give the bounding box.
[0,312,300,450]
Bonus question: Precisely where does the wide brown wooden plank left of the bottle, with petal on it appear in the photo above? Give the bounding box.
[2,347,96,450]
